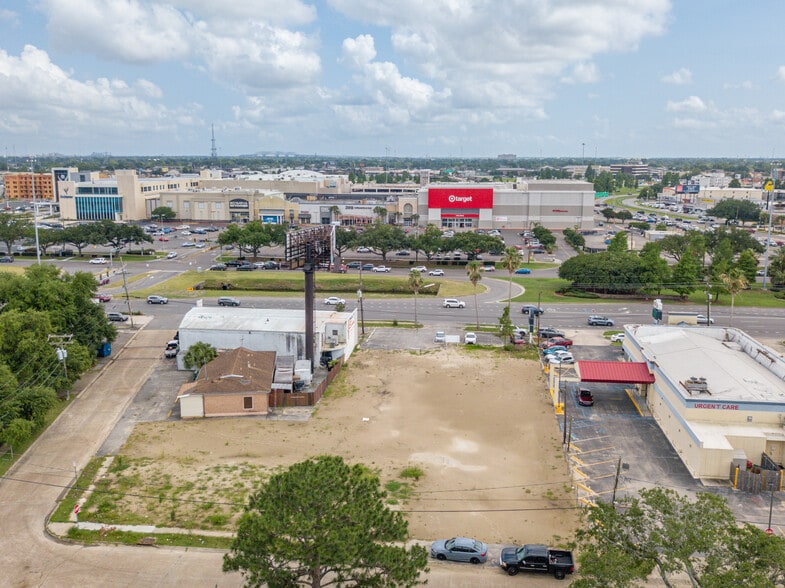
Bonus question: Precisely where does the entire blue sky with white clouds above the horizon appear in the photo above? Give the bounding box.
[0,0,785,160]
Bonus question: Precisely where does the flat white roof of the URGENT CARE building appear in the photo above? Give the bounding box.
[625,325,785,403]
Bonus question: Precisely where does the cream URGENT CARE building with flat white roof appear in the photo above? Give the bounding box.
[624,325,785,479]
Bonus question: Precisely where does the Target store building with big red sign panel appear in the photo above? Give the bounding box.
[417,180,594,229]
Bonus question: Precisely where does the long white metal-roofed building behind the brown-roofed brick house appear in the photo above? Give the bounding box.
[177,307,358,370]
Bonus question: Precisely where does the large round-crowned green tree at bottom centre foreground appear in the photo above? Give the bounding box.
[223,456,428,588]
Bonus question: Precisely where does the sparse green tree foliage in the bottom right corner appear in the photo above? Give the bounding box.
[572,488,785,588]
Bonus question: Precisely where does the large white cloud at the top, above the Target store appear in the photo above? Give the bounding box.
[328,0,670,120]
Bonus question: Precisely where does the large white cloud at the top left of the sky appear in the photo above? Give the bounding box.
[41,0,321,92]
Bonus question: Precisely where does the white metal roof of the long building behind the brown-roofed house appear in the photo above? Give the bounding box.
[180,306,352,333]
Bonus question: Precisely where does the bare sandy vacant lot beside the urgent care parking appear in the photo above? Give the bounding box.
[120,348,578,543]
